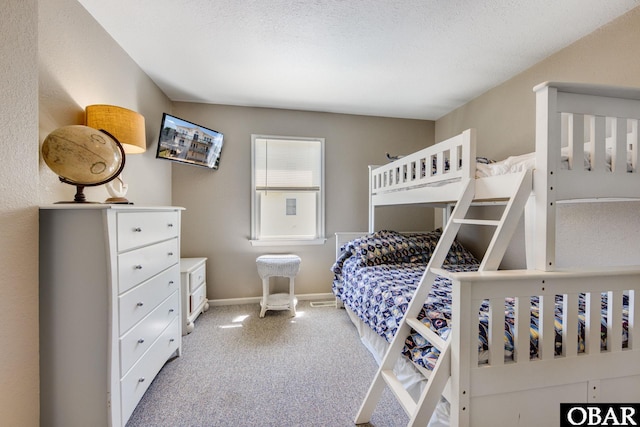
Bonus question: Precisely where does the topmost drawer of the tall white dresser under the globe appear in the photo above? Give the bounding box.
[117,211,180,252]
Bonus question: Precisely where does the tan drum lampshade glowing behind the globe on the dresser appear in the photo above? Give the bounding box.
[85,105,147,154]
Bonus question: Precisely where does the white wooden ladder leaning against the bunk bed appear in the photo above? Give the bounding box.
[355,171,532,427]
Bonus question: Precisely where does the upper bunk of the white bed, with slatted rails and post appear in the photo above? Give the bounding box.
[369,83,640,271]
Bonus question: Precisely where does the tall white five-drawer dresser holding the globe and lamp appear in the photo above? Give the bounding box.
[40,204,182,427]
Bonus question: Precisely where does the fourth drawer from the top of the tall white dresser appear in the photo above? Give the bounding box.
[120,292,180,375]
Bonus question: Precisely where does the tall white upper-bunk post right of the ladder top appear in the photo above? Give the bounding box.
[526,84,560,271]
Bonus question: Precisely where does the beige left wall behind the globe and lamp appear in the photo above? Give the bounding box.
[38,0,171,205]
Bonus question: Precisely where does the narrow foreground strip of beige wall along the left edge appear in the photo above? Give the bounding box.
[0,0,39,426]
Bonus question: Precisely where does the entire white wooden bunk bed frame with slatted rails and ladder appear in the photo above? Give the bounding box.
[337,83,640,426]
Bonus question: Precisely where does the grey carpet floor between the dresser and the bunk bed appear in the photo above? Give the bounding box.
[127,301,408,427]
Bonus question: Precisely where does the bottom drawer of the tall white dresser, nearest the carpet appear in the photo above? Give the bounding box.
[120,318,180,426]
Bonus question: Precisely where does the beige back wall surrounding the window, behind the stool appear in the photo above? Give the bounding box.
[173,103,434,299]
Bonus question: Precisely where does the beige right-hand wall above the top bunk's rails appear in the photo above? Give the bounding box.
[435,7,640,159]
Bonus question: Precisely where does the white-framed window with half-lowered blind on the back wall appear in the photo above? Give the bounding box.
[251,135,325,245]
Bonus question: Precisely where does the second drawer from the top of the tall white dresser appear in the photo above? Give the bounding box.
[118,238,180,293]
